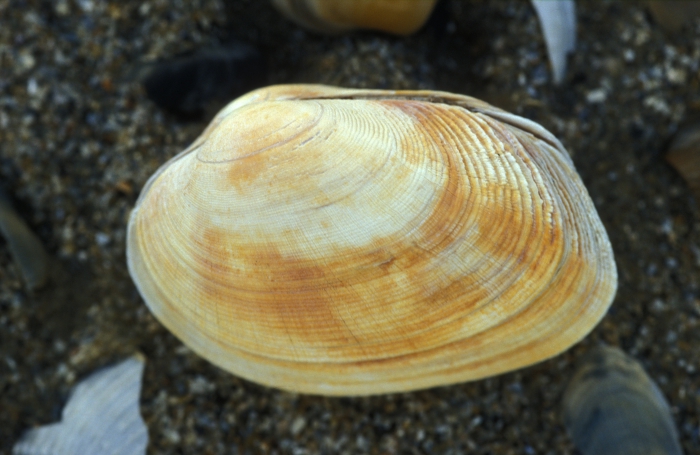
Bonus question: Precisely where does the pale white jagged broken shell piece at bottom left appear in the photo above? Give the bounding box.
[12,355,148,455]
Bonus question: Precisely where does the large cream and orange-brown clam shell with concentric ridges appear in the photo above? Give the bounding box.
[127,85,617,395]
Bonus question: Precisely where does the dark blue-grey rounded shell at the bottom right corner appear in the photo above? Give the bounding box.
[564,346,683,455]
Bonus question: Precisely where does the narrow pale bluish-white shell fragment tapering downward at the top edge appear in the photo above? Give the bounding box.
[532,0,576,84]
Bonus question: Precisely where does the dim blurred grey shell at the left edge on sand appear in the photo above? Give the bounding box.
[0,190,49,289]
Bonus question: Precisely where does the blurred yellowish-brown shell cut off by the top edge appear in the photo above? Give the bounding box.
[272,0,437,35]
